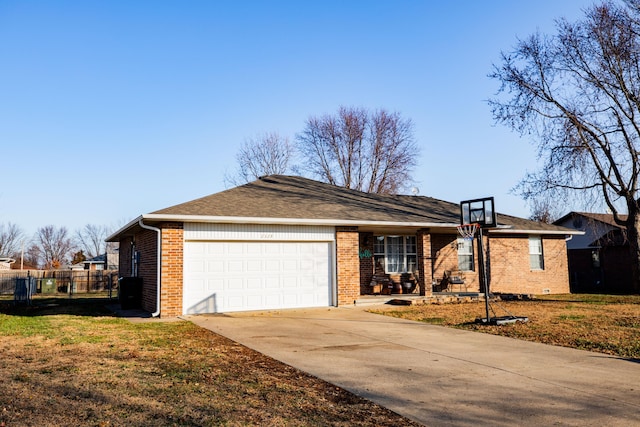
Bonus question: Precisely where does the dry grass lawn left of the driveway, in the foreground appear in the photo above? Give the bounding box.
[0,301,417,426]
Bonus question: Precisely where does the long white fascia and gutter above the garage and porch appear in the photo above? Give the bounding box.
[142,214,458,229]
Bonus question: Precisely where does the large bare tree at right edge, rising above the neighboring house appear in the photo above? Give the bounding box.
[490,0,640,291]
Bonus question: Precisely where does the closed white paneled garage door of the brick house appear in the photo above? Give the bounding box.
[183,242,331,314]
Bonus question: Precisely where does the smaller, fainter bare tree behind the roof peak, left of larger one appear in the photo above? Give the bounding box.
[224,132,293,185]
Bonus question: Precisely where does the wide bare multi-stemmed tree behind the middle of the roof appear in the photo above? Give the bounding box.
[296,107,418,193]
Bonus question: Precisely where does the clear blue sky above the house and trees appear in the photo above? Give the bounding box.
[0,0,592,235]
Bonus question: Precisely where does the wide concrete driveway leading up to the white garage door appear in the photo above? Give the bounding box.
[184,308,640,426]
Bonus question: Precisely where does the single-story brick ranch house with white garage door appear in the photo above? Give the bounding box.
[107,175,580,317]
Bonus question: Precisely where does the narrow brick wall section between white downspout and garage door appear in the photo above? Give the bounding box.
[160,223,184,317]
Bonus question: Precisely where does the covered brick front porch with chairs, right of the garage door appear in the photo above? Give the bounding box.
[336,224,483,305]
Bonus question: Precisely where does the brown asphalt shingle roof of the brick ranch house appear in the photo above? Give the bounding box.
[151,175,568,232]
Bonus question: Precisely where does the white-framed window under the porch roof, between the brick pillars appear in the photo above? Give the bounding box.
[373,236,417,273]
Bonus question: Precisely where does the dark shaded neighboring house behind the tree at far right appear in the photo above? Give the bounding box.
[554,212,633,293]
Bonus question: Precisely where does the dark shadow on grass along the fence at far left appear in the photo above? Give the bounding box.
[0,297,117,317]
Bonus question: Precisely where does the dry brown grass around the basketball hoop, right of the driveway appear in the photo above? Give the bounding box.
[371,295,640,359]
